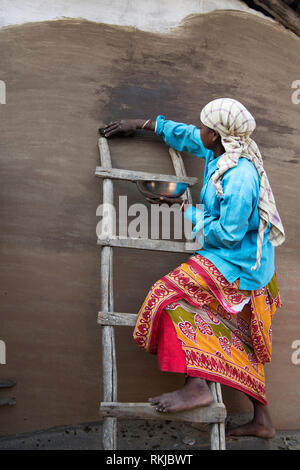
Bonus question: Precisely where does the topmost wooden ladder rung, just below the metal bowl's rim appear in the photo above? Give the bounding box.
[95,166,198,185]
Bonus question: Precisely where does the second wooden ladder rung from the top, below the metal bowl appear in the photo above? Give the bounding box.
[97,236,193,253]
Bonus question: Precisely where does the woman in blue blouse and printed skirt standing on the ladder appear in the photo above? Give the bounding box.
[104,98,285,438]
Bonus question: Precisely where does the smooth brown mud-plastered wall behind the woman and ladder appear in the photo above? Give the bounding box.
[0,12,300,434]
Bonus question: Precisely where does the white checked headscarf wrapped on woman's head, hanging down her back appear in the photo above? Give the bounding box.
[200,98,285,270]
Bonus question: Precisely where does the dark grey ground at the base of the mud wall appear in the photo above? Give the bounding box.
[0,414,300,452]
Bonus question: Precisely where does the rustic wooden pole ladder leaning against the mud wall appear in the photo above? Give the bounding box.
[95,137,226,450]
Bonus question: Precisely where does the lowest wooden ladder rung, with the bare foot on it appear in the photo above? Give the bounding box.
[99,402,226,424]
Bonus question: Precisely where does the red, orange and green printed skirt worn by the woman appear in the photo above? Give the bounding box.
[134,254,281,404]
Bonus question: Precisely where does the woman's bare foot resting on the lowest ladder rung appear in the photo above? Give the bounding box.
[149,377,213,413]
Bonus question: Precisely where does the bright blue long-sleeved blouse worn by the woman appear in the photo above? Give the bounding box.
[155,115,275,290]
